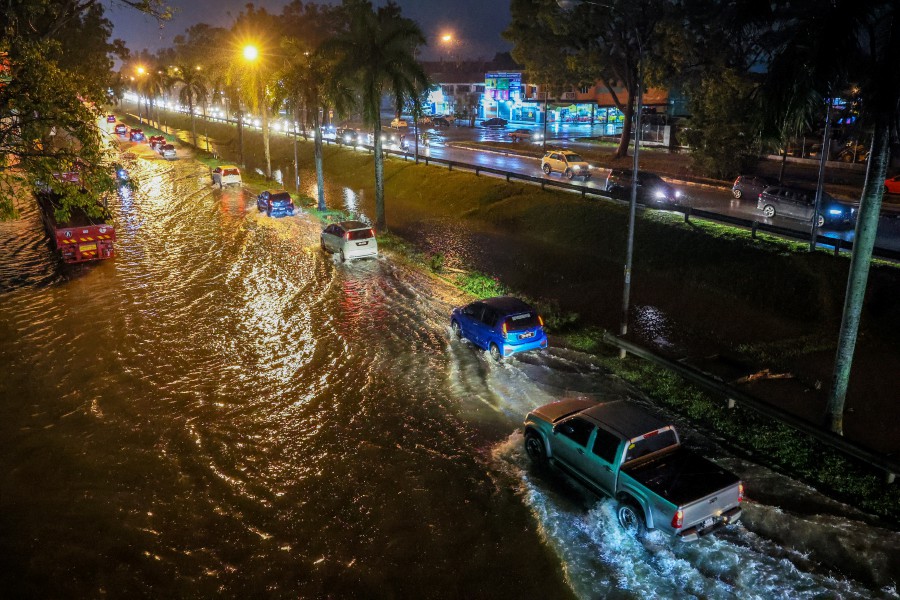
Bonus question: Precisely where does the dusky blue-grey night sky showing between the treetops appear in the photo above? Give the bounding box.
[107,0,510,60]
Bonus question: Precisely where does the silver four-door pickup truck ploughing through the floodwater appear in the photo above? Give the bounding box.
[525,399,744,541]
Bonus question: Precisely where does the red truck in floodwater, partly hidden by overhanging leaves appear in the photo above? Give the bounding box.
[35,173,116,263]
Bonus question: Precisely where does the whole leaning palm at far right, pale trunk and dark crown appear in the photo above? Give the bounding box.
[769,0,900,434]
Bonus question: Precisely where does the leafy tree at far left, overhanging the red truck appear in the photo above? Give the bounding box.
[0,0,166,218]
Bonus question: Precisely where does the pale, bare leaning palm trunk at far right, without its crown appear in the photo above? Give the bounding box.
[825,113,891,435]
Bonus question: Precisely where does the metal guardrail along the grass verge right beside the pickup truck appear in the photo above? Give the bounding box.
[603,333,900,483]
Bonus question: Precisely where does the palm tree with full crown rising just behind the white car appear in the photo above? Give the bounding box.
[323,0,428,230]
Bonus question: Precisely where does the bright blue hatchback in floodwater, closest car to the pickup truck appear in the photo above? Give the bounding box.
[450,296,547,361]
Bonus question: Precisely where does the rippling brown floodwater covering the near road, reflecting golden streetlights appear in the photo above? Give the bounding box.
[0,135,897,598]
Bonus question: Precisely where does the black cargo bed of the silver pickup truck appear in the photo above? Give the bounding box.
[621,446,740,506]
